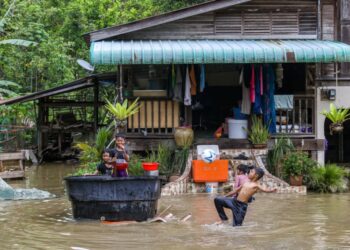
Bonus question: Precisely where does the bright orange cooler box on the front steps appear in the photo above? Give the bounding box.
[192,160,228,182]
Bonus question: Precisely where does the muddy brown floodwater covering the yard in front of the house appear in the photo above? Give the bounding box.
[0,164,350,250]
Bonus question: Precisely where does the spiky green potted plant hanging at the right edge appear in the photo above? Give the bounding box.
[321,103,350,135]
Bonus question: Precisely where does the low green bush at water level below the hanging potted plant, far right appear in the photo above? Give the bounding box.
[307,164,347,193]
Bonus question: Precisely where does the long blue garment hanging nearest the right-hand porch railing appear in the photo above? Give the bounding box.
[263,65,276,133]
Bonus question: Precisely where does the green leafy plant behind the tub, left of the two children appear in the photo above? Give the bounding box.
[76,128,112,166]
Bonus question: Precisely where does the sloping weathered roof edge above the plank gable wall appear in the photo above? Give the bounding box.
[83,0,251,45]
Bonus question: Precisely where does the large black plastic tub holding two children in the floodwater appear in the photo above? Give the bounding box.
[65,176,160,221]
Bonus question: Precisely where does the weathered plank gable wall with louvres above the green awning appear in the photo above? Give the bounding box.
[120,0,317,40]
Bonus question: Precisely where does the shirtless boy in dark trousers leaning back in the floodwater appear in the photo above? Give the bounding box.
[214,167,277,226]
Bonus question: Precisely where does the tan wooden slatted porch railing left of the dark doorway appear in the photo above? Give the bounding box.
[127,98,180,136]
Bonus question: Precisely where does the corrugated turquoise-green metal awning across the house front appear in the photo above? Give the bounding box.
[90,40,350,65]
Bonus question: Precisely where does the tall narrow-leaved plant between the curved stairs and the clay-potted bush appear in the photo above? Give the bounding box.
[267,137,295,177]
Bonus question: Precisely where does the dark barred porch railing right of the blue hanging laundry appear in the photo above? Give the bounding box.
[276,95,315,136]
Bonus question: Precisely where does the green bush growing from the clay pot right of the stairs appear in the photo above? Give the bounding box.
[283,151,317,178]
